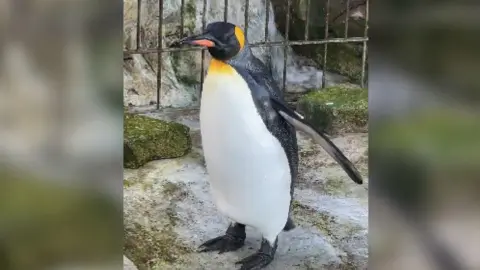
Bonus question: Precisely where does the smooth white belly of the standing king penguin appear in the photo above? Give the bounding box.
[200,71,291,239]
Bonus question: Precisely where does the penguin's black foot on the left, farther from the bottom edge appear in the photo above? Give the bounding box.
[199,223,246,254]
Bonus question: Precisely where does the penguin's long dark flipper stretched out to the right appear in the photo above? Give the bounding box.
[271,98,363,184]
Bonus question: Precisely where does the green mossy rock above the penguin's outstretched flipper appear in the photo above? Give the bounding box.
[297,86,368,135]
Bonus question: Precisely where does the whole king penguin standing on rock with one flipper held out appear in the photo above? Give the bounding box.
[177,22,362,270]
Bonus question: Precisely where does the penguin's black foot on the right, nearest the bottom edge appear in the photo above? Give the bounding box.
[235,239,278,270]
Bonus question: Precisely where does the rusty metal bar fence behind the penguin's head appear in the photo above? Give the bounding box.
[123,0,369,110]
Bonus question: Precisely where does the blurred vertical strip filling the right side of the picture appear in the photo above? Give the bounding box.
[369,0,480,269]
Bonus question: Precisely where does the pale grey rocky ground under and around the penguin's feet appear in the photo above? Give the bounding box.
[124,109,368,270]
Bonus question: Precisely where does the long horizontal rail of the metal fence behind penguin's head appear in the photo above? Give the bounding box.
[123,37,369,54]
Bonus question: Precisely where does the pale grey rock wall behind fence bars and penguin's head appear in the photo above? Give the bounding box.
[124,0,347,108]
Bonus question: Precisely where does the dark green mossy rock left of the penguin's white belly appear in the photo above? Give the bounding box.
[123,113,192,169]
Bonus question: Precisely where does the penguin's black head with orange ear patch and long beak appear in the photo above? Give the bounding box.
[180,22,245,61]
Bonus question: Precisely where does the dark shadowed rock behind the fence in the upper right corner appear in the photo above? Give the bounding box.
[271,0,366,83]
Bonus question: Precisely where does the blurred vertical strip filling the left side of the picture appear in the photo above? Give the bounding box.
[0,0,123,270]
